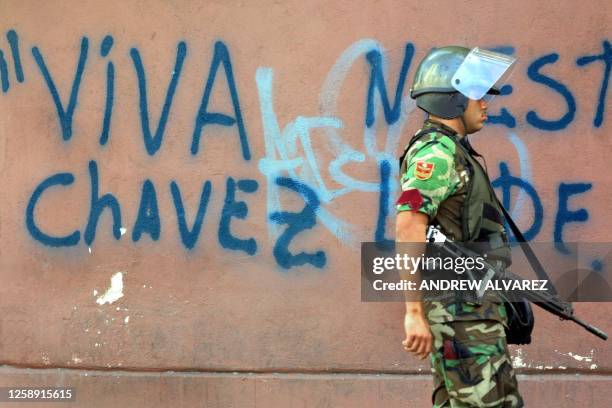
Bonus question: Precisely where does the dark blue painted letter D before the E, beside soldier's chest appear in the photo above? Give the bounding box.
[491,161,544,241]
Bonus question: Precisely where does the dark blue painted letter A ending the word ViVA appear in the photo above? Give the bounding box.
[191,41,251,160]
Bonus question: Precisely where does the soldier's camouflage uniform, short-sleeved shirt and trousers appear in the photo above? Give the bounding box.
[397,120,523,407]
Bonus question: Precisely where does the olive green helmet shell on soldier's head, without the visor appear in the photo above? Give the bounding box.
[410,46,499,119]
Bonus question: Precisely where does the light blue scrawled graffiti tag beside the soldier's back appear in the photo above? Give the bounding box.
[256,39,415,249]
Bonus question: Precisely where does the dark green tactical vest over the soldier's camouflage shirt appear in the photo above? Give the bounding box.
[400,122,511,266]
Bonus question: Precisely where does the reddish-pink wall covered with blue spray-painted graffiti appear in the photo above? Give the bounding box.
[0,0,612,407]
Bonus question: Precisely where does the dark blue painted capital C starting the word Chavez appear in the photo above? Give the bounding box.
[25,173,81,247]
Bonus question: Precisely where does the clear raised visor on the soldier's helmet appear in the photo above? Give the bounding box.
[451,47,516,101]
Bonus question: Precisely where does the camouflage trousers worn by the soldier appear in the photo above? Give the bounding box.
[430,320,524,408]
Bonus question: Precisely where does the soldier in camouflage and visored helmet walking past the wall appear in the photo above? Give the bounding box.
[396,46,523,407]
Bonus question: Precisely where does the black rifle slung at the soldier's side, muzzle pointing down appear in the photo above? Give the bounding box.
[427,226,608,340]
